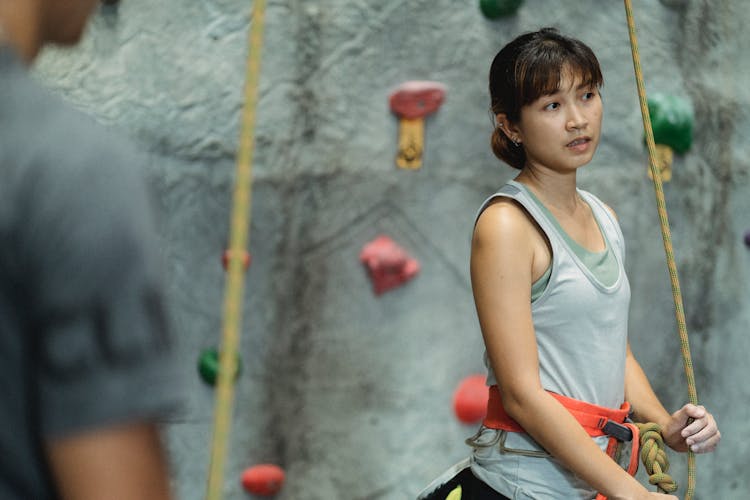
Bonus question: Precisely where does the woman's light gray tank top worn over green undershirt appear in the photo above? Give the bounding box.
[470,181,630,499]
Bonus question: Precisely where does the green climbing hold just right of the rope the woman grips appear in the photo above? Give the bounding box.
[648,93,695,153]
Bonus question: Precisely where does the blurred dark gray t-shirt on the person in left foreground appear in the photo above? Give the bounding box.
[0,47,181,499]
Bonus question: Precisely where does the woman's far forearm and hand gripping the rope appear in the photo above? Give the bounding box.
[625,345,721,453]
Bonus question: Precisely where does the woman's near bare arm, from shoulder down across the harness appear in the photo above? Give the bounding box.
[471,200,674,499]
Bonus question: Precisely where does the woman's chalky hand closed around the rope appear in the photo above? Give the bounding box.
[662,404,721,453]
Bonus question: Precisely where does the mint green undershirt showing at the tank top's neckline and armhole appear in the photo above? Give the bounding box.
[524,186,620,302]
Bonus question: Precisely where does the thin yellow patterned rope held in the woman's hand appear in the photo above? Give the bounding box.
[624,0,698,500]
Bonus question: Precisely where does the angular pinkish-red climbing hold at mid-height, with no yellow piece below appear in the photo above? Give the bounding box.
[359,236,419,295]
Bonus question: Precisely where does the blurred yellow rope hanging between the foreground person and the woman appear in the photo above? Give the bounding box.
[206,0,266,500]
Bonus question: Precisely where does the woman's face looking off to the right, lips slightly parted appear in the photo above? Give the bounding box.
[517,68,602,172]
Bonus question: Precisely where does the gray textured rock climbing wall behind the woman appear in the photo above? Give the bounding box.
[37,0,750,500]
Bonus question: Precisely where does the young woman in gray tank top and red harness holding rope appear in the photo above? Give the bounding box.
[425,28,720,500]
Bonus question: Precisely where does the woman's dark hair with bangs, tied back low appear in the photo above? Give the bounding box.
[490,28,604,169]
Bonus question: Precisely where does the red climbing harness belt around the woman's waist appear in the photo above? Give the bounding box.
[482,385,639,500]
